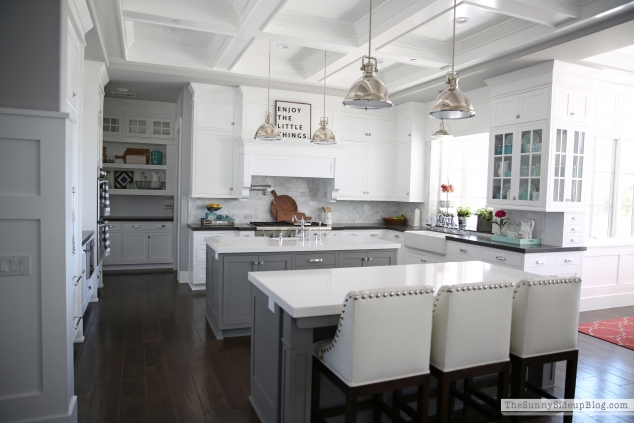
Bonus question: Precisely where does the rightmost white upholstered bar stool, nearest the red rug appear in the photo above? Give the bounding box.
[511,278,581,422]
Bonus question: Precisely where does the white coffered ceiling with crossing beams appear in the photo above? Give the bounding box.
[88,0,634,102]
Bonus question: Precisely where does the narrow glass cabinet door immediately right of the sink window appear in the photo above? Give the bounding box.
[489,130,515,202]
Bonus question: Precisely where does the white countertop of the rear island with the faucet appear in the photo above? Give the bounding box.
[205,237,401,254]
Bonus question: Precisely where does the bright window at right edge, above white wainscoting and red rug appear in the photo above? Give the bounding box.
[586,138,634,238]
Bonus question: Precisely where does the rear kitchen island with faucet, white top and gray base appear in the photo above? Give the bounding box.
[205,237,401,339]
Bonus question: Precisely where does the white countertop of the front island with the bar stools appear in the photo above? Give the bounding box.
[249,261,540,318]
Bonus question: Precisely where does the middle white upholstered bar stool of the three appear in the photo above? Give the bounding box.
[430,281,513,422]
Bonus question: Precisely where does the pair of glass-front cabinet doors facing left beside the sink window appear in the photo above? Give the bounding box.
[488,124,548,207]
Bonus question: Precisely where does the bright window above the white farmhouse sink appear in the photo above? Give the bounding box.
[438,133,489,212]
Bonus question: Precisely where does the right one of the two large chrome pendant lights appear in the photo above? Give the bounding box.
[429,0,475,119]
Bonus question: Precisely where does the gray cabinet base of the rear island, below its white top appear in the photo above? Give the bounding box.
[206,246,396,339]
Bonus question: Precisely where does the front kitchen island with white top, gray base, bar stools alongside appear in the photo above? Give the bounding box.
[249,261,538,423]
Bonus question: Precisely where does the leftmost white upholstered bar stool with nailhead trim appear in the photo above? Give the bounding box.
[311,286,434,423]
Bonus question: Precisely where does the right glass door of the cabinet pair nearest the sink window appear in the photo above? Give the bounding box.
[517,128,545,203]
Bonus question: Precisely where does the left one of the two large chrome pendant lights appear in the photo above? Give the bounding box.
[343,0,392,110]
